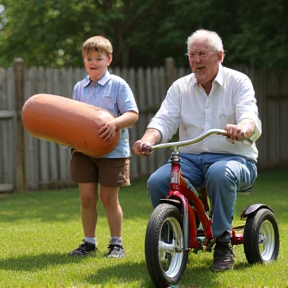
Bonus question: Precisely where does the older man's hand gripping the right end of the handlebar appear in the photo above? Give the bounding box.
[225,119,255,144]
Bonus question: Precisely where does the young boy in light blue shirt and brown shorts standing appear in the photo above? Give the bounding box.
[69,36,138,258]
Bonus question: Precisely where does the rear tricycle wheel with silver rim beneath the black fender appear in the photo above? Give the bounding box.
[243,208,280,264]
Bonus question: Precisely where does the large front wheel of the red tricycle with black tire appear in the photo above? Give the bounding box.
[145,203,189,288]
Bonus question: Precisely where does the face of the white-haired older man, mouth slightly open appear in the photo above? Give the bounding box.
[187,41,224,85]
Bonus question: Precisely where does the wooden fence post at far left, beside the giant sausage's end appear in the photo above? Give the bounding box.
[14,58,25,192]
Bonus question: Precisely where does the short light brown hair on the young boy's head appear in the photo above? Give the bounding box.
[82,36,113,58]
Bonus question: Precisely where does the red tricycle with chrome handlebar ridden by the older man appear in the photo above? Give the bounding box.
[145,129,280,287]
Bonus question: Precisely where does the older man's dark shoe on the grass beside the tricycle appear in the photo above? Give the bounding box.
[211,235,234,272]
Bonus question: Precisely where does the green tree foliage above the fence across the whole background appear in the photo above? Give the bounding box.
[0,0,288,69]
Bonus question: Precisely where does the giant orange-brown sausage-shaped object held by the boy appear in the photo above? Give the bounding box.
[22,94,119,157]
